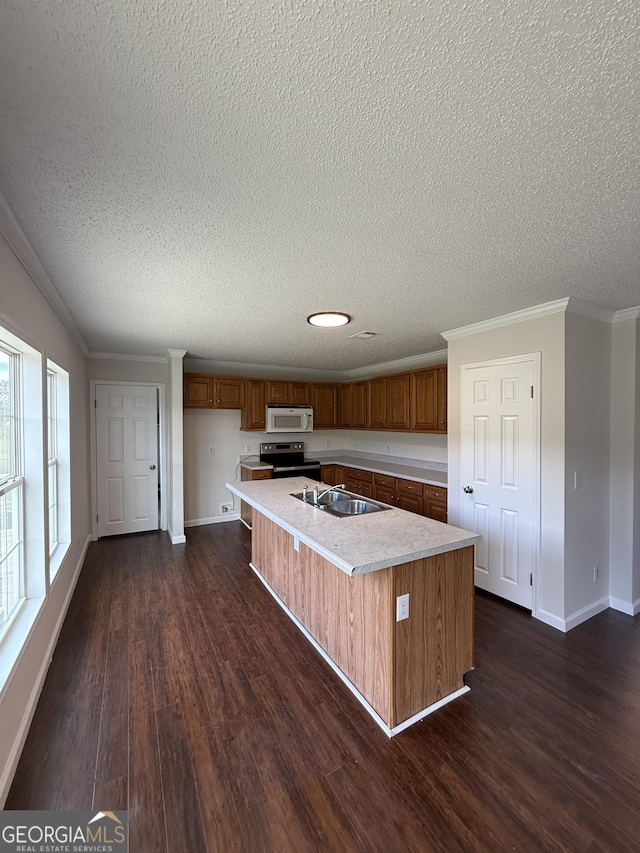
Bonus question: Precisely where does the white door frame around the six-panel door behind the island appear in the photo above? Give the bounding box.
[458,352,542,619]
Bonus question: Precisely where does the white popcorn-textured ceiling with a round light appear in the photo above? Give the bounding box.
[0,0,640,370]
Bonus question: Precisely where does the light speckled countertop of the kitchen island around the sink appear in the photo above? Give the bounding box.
[226,477,481,575]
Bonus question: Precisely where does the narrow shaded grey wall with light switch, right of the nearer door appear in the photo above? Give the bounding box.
[564,311,611,628]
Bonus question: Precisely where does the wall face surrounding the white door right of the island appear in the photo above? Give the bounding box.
[448,312,565,628]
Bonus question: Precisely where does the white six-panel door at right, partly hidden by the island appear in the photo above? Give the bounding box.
[460,354,540,610]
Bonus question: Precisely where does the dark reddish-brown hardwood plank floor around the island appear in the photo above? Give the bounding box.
[6,522,640,853]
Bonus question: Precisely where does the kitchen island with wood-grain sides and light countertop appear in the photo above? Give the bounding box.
[227,477,480,736]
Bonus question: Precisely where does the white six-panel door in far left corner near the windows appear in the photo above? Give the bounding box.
[95,385,159,536]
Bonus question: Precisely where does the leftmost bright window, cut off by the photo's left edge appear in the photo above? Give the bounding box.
[0,346,25,638]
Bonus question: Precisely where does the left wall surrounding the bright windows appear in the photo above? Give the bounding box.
[0,238,90,805]
